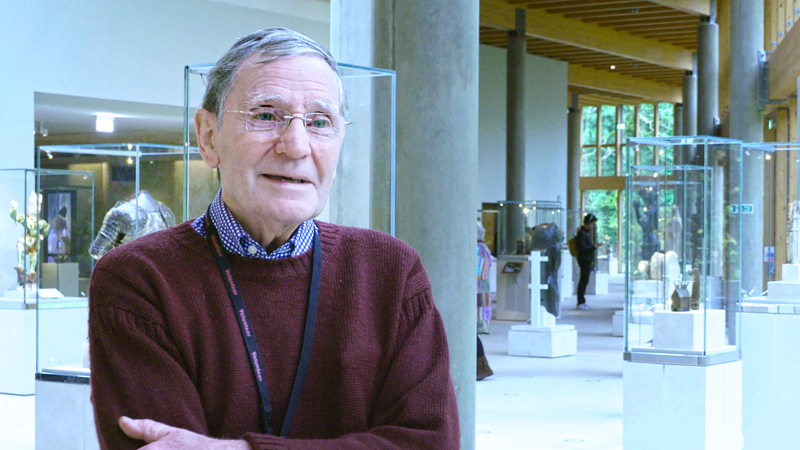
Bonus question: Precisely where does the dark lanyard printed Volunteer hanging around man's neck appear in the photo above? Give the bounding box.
[205,212,322,437]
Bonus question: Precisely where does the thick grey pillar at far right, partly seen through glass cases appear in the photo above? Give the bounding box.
[730,0,765,294]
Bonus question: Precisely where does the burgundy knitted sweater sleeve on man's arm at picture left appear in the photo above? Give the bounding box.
[89,268,208,450]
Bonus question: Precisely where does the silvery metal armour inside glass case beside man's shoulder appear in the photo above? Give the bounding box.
[89,191,175,260]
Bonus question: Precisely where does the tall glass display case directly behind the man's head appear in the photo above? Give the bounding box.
[184,63,396,235]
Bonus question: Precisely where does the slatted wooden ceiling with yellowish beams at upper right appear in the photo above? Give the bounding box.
[480,0,711,104]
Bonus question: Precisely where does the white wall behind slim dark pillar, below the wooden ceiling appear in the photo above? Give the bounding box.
[477,45,567,208]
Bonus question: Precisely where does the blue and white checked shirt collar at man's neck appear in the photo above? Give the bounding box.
[192,189,317,259]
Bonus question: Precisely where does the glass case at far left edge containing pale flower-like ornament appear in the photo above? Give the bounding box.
[0,169,95,309]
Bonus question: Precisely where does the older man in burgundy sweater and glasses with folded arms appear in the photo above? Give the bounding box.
[89,28,459,449]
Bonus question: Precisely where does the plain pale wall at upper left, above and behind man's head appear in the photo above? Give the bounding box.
[0,0,329,168]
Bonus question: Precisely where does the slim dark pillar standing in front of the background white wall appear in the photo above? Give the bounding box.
[501,8,527,253]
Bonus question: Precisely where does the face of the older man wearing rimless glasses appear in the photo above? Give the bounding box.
[197,55,344,227]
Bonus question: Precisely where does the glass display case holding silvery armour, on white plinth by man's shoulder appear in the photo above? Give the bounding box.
[31,143,200,376]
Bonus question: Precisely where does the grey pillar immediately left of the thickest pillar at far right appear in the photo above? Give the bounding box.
[697,21,719,136]
